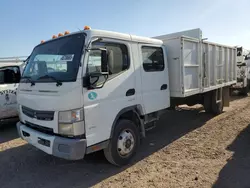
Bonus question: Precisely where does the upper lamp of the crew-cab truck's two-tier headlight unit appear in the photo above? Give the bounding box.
[58,108,83,123]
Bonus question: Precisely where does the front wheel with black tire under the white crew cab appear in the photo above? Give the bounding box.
[104,119,140,166]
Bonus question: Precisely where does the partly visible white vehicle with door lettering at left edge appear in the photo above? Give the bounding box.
[0,57,26,122]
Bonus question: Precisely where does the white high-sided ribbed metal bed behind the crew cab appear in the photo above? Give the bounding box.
[156,31,236,97]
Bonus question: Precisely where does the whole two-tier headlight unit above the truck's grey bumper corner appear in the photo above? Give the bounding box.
[58,109,85,136]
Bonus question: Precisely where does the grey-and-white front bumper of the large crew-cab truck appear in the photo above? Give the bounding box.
[16,122,87,160]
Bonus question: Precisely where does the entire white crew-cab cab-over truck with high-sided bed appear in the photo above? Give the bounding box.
[17,27,236,166]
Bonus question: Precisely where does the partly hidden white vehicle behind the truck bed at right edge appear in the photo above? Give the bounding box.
[231,46,250,95]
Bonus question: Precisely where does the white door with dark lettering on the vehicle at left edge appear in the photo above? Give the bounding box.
[0,66,21,119]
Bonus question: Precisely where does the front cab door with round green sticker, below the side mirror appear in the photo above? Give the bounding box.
[84,39,136,146]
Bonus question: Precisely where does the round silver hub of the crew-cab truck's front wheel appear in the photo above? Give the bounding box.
[117,130,135,156]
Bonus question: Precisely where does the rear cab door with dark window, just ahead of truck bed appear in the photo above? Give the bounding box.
[139,44,170,114]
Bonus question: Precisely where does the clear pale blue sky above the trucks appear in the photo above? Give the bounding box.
[0,0,250,57]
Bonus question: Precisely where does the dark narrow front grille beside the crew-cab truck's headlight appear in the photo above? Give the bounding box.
[22,106,55,121]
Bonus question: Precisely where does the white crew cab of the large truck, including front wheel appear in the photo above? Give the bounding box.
[17,28,170,165]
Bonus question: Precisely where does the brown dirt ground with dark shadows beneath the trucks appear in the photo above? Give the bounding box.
[0,97,250,188]
